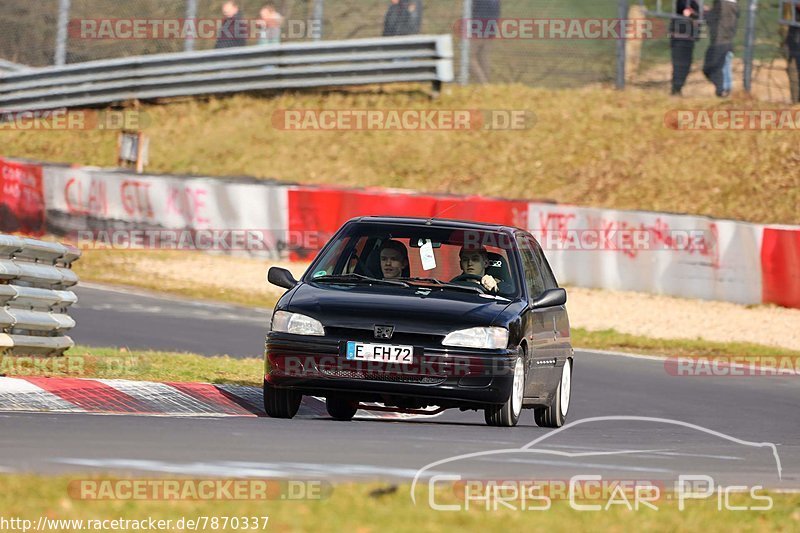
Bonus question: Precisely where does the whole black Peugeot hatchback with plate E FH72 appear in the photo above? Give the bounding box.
[264,217,573,427]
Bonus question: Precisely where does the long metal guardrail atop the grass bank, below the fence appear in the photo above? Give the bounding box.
[0,35,453,111]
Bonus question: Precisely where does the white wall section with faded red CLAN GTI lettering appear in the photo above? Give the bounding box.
[43,166,289,256]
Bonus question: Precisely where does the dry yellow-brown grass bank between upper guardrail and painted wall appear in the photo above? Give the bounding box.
[0,85,800,224]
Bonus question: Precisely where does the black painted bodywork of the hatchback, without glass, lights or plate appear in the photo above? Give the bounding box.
[265,217,572,409]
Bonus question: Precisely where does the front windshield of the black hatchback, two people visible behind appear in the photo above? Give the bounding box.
[304,219,519,298]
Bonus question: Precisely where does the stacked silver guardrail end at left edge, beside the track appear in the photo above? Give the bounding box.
[0,234,81,355]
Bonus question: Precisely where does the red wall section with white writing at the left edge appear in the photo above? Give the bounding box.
[0,159,44,235]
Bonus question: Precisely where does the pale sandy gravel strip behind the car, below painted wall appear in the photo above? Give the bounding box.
[83,254,800,350]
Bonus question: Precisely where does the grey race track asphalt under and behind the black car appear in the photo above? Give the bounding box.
[0,287,800,489]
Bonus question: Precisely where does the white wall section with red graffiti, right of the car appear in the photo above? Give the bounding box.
[528,203,763,304]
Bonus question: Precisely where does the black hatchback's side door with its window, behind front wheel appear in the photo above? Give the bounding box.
[517,235,557,398]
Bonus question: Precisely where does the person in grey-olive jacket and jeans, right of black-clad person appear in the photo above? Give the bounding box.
[703,0,739,97]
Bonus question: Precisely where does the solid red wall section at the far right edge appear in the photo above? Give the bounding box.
[761,228,800,308]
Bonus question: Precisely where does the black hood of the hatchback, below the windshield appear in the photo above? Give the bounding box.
[286,282,511,334]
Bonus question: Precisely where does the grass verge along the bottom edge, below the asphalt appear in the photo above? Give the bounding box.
[0,475,800,533]
